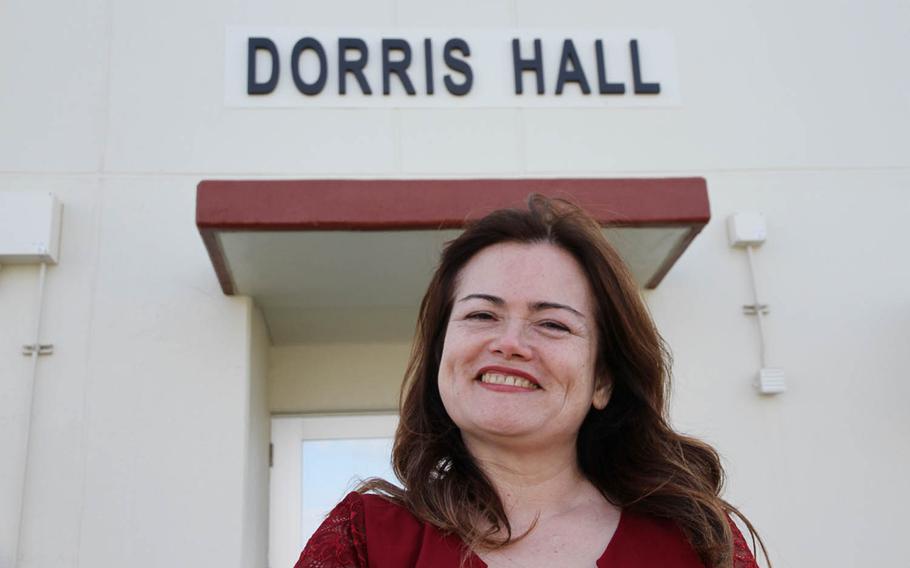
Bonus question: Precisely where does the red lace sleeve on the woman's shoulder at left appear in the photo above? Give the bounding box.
[294,493,367,568]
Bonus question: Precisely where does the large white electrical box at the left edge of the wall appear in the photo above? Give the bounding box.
[0,191,63,264]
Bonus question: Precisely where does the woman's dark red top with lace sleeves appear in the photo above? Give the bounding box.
[294,493,758,568]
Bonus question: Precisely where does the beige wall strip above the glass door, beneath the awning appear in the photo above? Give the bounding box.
[269,341,411,413]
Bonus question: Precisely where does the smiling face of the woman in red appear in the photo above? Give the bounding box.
[439,243,609,448]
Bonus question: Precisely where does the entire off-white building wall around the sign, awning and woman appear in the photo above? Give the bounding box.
[0,0,910,568]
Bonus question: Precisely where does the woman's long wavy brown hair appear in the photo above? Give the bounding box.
[360,195,767,568]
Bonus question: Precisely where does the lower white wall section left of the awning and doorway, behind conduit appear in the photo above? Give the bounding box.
[0,179,264,567]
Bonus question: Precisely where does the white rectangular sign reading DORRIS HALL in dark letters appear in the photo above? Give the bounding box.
[225,27,681,108]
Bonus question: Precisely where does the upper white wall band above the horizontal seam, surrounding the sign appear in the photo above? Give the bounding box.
[0,0,910,177]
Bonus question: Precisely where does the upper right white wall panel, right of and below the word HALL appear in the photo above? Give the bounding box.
[518,1,910,173]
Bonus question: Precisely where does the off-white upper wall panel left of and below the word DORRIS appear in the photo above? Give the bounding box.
[107,2,395,175]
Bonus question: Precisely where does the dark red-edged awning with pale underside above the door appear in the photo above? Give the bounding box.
[196,178,710,345]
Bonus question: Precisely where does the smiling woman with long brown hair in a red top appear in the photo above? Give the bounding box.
[296,196,767,568]
